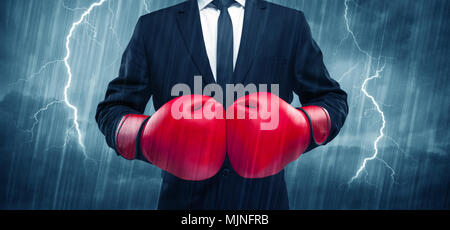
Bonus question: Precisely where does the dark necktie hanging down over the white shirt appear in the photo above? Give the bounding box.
[212,0,235,91]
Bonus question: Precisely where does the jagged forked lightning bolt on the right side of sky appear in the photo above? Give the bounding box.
[341,0,395,185]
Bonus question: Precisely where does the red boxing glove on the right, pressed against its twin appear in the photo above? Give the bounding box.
[227,93,331,178]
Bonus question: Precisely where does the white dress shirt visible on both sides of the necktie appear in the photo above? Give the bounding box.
[198,0,245,81]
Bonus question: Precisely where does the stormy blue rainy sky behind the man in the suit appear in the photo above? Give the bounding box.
[0,0,450,209]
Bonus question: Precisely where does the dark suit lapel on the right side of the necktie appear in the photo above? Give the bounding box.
[233,0,267,84]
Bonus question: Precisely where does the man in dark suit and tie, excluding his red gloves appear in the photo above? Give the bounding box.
[96,0,348,209]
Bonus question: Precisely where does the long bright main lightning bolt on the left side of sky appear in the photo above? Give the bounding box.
[64,0,107,156]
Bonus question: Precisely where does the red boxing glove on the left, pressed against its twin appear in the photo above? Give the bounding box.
[116,95,226,181]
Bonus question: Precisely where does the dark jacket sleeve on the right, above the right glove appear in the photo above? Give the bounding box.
[293,12,348,151]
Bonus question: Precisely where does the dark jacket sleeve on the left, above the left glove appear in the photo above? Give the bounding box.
[95,18,152,160]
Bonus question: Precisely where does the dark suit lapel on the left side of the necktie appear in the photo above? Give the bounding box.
[177,0,215,84]
